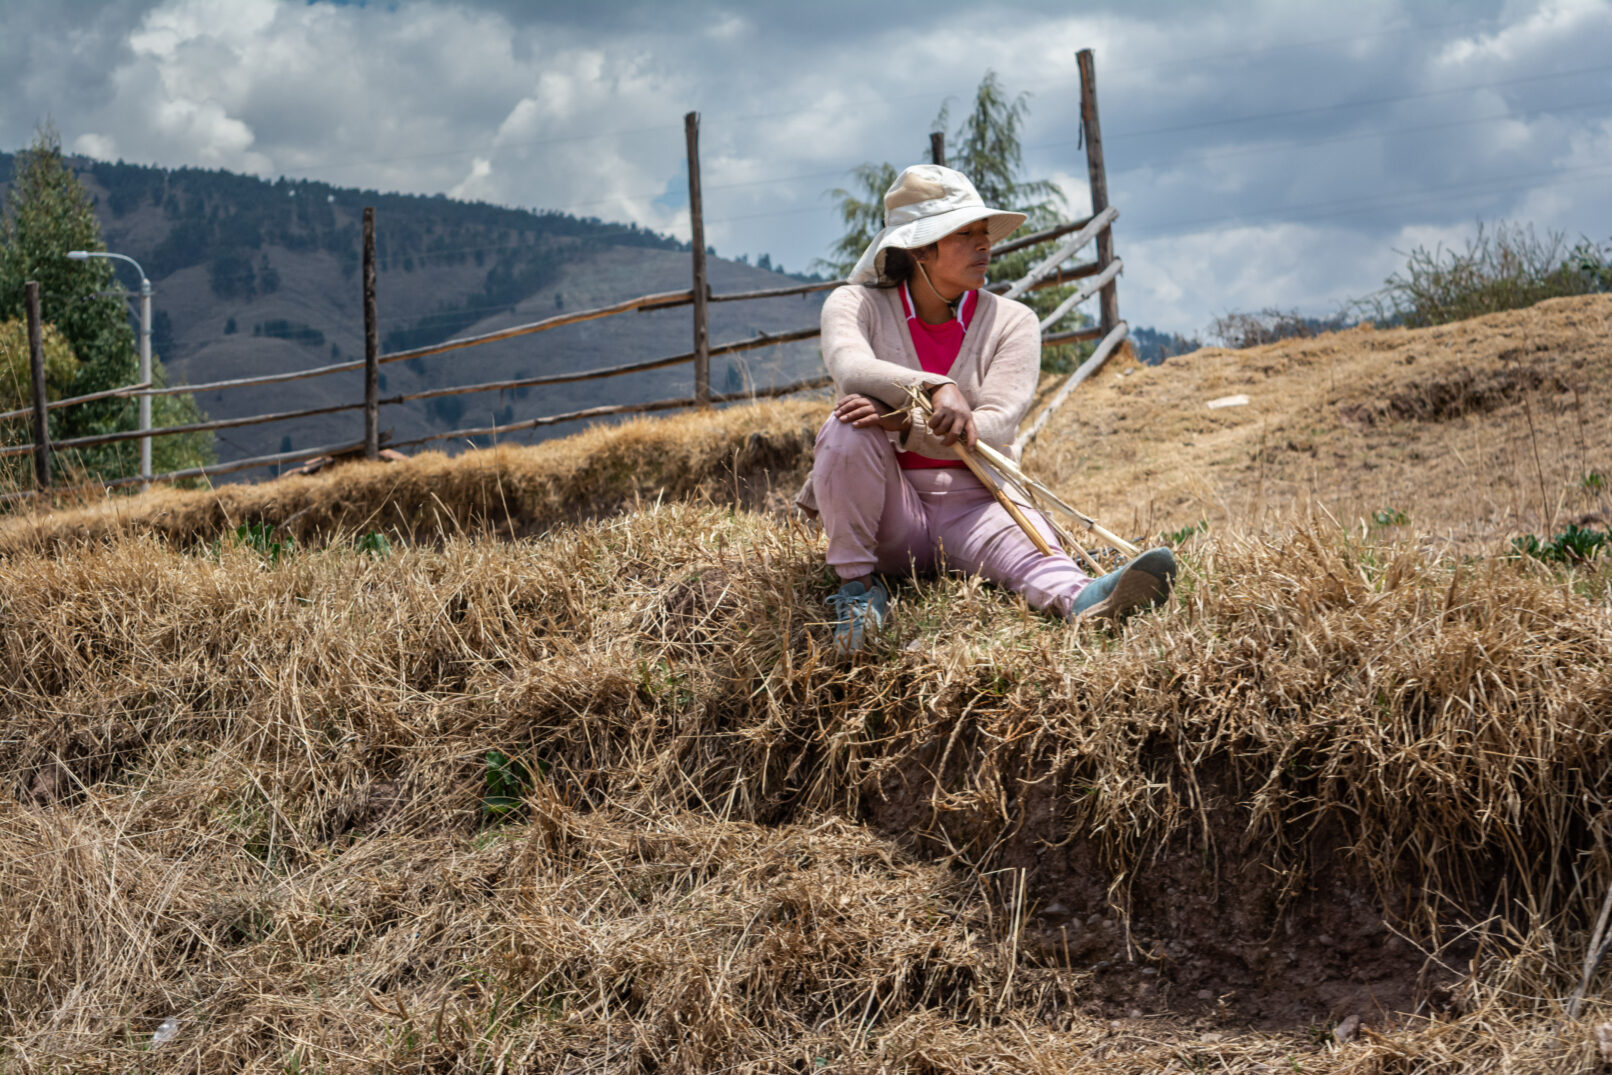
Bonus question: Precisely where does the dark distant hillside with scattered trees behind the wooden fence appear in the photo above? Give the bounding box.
[0,155,822,461]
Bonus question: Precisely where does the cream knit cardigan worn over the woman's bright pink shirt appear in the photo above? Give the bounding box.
[795,285,1041,514]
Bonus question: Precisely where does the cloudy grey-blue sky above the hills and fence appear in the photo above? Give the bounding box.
[0,0,1612,332]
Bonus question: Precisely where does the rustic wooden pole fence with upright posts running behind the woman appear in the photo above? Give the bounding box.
[9,50,1128,500]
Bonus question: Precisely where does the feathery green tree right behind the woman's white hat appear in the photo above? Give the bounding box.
[814,71,1091,372]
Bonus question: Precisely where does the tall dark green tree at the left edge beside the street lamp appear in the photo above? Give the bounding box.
[0,124,214,479]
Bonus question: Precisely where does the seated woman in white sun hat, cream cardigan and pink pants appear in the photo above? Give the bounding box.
[796,164,1175,651]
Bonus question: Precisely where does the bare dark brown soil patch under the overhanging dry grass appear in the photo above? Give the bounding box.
[864,751,1472,1030]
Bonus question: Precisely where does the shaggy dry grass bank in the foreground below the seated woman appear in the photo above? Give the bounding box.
[0,493,1612,1072]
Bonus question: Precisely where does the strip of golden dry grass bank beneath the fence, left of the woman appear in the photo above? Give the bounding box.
[0,400,824,553]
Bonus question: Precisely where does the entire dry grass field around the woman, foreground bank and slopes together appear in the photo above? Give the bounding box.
[0,300,1612,1073]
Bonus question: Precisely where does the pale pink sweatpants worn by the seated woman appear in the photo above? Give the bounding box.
[812,416,1091,617]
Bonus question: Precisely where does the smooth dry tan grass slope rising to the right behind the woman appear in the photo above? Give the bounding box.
[1027,295,1612,551]
